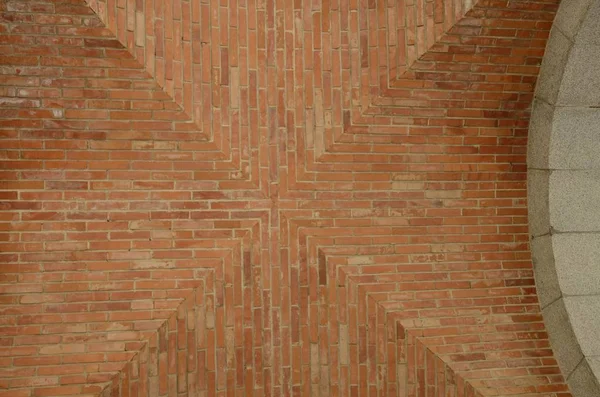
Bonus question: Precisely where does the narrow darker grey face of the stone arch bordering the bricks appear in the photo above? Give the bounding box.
[527,0,600,397]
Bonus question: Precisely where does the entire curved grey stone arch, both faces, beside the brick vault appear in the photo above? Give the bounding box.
[528,0,600,397]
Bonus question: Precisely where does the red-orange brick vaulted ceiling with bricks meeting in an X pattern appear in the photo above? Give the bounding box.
[0,0,570,397]
